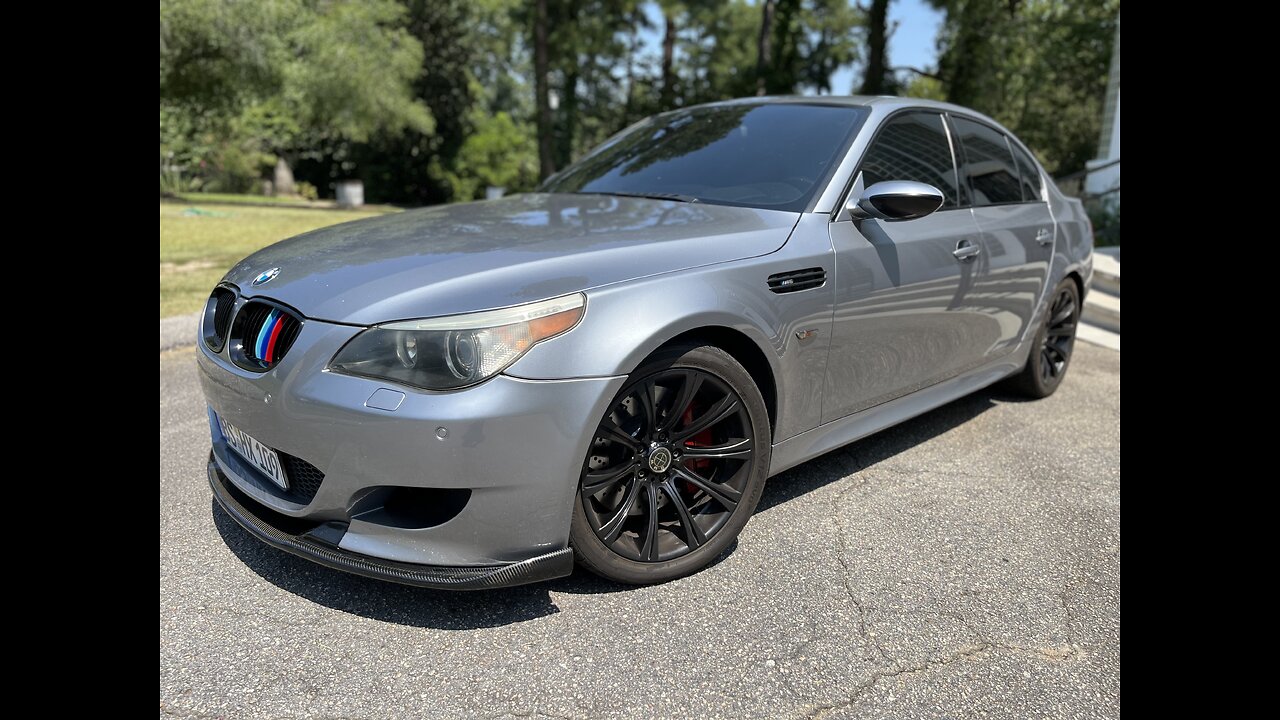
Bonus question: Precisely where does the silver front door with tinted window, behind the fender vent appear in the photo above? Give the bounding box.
[822,111,998,421]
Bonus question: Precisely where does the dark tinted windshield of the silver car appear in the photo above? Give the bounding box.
[540,104,865,211]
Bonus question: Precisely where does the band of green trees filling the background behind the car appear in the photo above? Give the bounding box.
[160,0,1119,199]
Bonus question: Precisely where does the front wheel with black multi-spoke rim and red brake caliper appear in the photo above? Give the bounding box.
[570,345,772,584]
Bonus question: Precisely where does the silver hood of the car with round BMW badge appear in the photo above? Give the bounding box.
[224,193,799,325]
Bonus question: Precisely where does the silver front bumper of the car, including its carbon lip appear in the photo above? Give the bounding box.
[197,310,625,576]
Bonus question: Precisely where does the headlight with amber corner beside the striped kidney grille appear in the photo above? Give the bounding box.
[329,293,586,389]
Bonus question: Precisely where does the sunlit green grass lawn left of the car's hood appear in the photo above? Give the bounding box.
[160,202,383,318]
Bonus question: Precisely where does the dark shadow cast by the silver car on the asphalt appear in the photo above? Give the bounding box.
[210,389,1020,630]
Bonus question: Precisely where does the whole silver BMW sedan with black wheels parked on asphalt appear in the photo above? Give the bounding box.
[198,97,1093,589]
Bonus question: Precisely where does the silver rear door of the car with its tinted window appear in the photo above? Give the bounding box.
[951,115,1053,359]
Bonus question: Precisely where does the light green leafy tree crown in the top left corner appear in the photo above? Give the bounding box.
[160,0,433,192]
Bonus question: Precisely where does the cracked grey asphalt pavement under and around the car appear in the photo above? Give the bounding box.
[160,343,1120,719]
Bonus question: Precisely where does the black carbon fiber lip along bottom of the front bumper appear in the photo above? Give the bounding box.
[209,455,573,591]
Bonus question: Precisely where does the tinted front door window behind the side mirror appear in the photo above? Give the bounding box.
[861,113,960,208]
